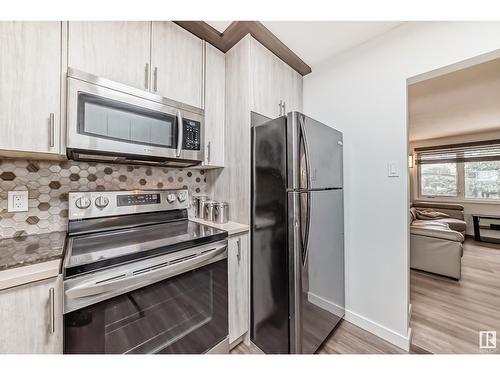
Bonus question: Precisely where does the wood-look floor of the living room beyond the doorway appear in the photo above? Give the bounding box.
[410,238,500,354]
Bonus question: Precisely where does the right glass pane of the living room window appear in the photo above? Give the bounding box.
[464,160,500,200]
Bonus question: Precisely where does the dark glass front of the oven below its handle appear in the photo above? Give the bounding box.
[64,259,228,354]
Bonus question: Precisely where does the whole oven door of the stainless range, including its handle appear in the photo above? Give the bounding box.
[64,241,228,354]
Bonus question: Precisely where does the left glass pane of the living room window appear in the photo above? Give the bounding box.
[420,163,458,197]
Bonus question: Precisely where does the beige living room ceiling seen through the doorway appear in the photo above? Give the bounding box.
[408,59,500,141]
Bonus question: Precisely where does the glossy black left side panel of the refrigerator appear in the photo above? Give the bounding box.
[251,117,290,354]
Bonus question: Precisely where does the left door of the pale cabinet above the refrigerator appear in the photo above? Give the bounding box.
[250,39,283,118]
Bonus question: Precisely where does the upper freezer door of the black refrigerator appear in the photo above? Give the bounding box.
[287,112,343,190]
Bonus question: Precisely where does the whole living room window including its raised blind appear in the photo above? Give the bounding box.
[415,140,500,202]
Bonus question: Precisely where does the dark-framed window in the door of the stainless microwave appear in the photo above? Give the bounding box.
[78,93,177,148]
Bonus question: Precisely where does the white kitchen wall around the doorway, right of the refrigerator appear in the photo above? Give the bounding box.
[304,22,500,347]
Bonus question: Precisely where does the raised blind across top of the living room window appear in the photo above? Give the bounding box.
[415,139,500,164]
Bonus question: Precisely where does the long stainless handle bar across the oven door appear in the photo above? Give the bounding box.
[65,245,227,299]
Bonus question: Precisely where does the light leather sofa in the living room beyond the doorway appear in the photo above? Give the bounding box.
[410,205,465,280]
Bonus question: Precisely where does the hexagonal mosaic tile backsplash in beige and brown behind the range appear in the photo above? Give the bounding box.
[0,159,206,238]
